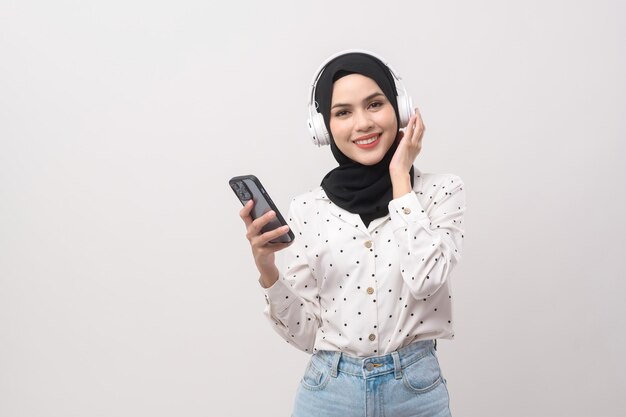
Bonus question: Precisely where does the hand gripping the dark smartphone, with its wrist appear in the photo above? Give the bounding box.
[239,200,292,287]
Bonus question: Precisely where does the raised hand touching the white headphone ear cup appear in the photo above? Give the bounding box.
[389,107,424,179]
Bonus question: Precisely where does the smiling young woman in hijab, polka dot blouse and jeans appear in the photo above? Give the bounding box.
[240,51,465,417]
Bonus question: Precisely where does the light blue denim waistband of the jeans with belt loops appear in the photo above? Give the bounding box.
[311,340,436,379]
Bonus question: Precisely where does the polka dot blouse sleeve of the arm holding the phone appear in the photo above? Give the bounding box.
[261,198,321,353]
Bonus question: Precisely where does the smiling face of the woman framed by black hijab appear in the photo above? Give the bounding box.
[330,74,398,165]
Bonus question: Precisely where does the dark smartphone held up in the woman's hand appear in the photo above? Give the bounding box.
[228,175,295,243]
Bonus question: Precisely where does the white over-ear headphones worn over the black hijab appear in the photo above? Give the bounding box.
[307,49,415,146]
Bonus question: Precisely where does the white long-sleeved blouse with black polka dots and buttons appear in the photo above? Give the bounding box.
[261,168,465,357]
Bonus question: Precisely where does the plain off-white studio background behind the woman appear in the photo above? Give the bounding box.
[0,0,626,417]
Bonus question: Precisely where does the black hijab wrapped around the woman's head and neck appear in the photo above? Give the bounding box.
[315,52,413,227]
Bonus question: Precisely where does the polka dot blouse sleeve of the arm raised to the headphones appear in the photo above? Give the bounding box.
[389,174,465,299]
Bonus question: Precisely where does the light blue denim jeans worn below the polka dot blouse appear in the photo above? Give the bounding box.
[292,340,451,417]
